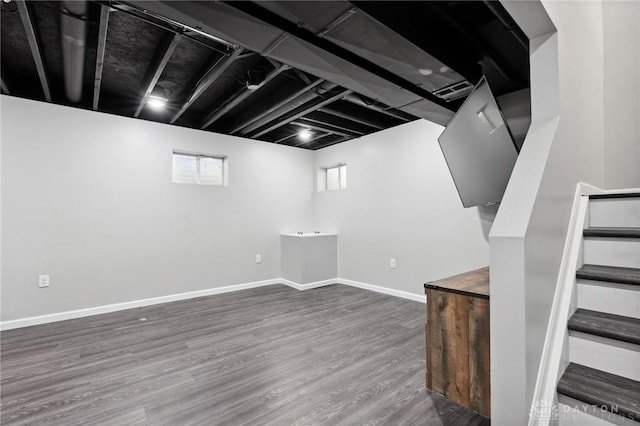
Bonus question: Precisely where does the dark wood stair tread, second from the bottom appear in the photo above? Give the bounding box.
[568,309,640,345]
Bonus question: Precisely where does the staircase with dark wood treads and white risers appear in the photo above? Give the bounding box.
[557,193,640,425]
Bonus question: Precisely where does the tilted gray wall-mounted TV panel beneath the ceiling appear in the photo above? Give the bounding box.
[438,78,518,207]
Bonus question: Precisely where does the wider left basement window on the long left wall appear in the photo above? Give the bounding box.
[173,151,228,186]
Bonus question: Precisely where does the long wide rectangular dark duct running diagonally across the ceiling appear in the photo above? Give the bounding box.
[128,0,455,125]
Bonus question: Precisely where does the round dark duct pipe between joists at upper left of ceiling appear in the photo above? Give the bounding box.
[60,0,87,103]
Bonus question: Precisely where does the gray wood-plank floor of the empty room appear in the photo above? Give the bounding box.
[0,285,489,426]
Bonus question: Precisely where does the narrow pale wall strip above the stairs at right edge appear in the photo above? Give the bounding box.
[602,0,640,189]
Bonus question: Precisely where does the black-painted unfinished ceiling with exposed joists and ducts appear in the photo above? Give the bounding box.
[1,0,529,149]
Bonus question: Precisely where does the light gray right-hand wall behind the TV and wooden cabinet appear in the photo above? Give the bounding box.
[315,120,493,294]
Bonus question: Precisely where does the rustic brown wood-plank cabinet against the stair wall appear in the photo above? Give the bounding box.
[424,267,491,417]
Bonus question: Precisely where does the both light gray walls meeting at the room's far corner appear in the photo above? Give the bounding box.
[1,96,494,321]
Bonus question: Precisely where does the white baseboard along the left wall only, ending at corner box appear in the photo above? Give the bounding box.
[0,278,282,331]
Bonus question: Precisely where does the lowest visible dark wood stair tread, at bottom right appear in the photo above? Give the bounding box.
[557,363,640,422]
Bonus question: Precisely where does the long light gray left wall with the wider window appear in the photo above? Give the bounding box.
[1,96,315,321]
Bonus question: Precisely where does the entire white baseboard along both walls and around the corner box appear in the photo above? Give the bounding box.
[0,278,425,331]
